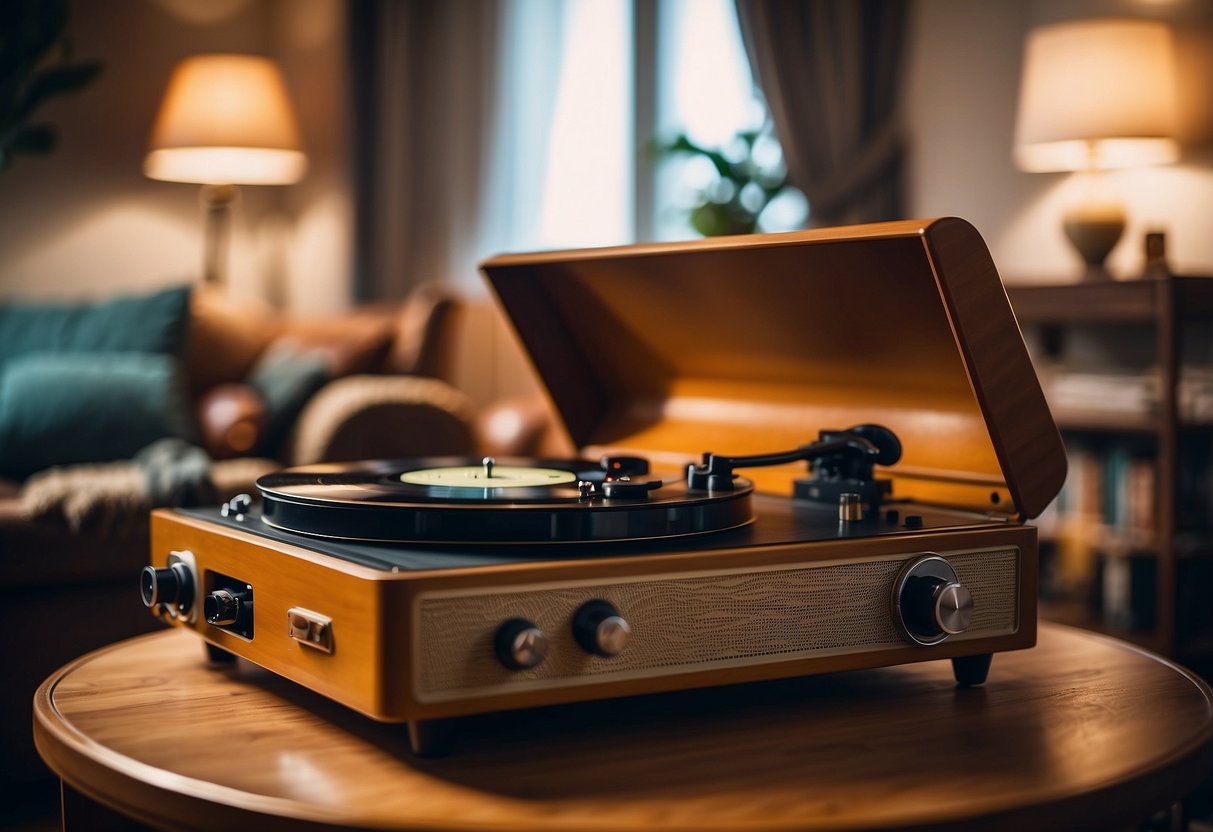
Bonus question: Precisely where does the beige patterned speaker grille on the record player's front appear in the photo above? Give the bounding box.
[414,548,1019,702]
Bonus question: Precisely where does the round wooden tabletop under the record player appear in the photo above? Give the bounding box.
[34,625,1213,831]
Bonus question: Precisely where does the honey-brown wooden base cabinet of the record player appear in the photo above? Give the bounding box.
[152,511,1038,722]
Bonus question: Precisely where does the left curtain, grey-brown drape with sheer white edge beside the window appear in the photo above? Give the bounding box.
[349,0,634,300]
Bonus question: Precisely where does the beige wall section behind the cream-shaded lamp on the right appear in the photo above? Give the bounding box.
[905,0,1213,281]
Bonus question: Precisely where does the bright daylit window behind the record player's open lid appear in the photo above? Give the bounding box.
[484,0,807,257]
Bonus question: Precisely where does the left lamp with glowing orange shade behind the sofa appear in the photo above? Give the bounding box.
[143,55,307,283]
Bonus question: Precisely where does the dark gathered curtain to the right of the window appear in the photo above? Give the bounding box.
[736,0,906,226]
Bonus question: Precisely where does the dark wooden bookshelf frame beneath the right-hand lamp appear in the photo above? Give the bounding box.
[1007,277,1213,657]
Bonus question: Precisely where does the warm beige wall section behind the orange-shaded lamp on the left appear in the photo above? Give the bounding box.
[0,0,352,309]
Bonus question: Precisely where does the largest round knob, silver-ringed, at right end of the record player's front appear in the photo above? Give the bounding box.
[893,554,973,644]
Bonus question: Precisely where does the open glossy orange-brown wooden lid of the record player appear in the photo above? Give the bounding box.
[483,218,1065,518]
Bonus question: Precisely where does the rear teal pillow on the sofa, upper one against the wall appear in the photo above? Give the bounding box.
[0,286,189,364]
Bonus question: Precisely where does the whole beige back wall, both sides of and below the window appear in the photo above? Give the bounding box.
[0,0,1213,401]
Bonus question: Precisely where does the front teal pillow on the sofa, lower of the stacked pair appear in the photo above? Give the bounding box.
[0,353,195,479]
